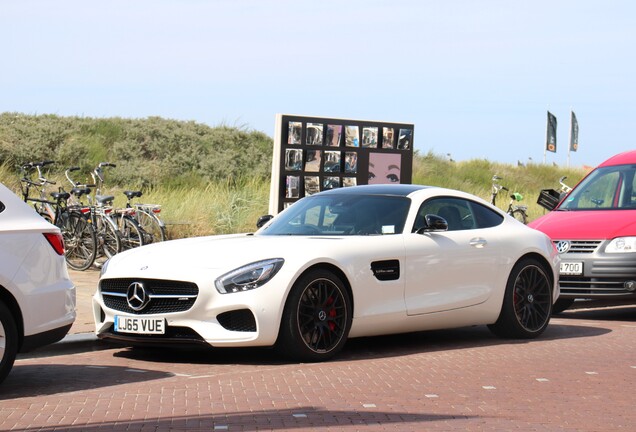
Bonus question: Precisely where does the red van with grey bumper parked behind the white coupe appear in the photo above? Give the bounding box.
[528,150,636,313]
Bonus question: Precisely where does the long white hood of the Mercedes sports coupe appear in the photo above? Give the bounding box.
[108,234,350,273]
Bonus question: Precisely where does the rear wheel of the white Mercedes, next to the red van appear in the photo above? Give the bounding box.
[488,258,552,339]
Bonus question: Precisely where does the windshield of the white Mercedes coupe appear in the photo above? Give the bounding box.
[259,194,411,236]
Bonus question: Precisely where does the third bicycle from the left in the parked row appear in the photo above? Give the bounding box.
[91,162,148,251]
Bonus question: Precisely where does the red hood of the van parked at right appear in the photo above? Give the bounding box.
[528,210,636,240]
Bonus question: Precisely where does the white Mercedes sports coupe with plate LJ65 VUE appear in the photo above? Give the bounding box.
[93,185,559,361]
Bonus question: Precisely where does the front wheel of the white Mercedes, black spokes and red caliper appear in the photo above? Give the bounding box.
[277,269,353,362]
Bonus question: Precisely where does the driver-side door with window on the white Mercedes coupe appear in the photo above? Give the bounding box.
[405,197,503,315]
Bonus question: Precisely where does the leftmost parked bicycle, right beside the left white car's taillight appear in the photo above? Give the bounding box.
[20,161,97,271]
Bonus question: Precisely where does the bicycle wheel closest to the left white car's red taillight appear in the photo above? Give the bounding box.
[57,212,97,271]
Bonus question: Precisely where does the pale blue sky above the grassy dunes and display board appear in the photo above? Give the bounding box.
[0,0,636,166]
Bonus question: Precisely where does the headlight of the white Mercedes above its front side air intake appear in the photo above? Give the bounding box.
[214,258,285,294]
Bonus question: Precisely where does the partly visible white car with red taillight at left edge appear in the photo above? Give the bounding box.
[0,183,75,382]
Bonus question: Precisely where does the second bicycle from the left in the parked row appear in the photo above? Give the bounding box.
[64,167,122,264]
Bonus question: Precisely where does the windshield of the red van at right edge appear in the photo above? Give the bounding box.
[558,165,636,210]
